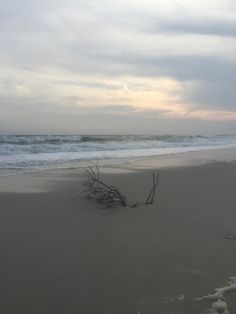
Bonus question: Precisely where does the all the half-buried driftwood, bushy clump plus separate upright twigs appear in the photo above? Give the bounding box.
[84,161,159,208]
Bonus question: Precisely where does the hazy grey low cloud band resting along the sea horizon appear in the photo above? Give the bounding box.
[0,99,236,134]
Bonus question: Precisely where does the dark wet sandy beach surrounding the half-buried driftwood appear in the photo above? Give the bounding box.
[0,149,236,314]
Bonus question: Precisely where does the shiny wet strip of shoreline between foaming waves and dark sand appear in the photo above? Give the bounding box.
[0,147,236,180]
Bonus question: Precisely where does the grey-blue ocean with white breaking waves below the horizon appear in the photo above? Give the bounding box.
[0,135,236,169]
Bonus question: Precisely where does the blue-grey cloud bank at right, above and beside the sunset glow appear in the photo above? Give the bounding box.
[91,56,236,110]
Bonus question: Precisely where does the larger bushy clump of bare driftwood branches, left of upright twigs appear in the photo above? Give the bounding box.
[84,162,127,207]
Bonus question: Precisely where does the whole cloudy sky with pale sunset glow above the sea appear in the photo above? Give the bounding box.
[0,0,236,134]
